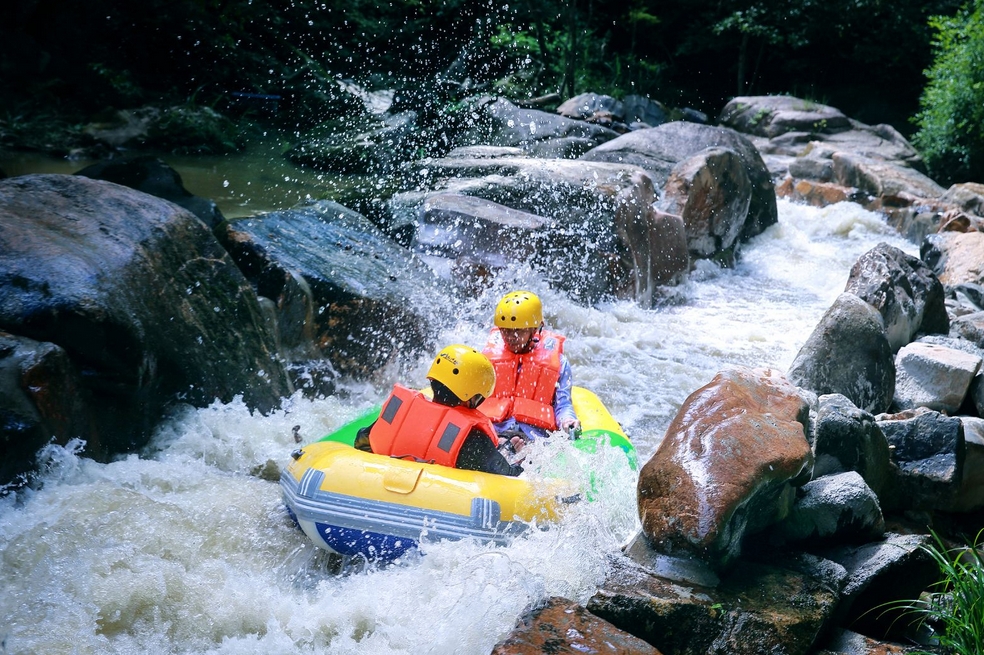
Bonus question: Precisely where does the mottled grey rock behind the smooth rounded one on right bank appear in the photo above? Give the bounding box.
[844,243,950,352]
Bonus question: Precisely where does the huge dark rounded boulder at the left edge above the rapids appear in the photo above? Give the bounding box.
[0,175,292,472]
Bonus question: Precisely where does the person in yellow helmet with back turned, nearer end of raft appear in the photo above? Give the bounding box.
[355,344,523,476]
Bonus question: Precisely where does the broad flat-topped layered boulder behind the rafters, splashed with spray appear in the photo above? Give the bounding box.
[389,158,689,306]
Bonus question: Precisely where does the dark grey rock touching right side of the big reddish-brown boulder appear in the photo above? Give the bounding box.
[813,394,892,494]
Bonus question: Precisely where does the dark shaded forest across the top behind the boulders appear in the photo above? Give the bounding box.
[0,0,984,183]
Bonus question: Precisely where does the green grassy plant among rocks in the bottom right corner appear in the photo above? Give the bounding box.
[891,531,984,655]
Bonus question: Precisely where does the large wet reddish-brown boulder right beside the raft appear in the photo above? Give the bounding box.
[638,368,813,569]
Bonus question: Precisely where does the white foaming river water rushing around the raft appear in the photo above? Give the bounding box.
[0,152,917,655]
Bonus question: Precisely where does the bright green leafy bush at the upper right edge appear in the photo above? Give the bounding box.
[913,0,984,182]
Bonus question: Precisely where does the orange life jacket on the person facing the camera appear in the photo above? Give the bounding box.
[478,328,564,430]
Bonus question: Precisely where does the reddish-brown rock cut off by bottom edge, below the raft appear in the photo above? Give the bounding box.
[492,596,659,655]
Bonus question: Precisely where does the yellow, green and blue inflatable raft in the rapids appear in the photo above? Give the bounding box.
[280,387,637,560]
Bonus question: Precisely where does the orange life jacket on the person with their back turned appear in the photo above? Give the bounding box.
[369,384,498,467]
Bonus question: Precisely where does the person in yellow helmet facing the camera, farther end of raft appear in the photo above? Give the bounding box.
[480,291,581,450]
